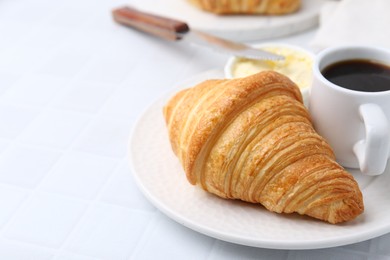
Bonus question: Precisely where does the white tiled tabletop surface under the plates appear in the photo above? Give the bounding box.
[0,0,390,260]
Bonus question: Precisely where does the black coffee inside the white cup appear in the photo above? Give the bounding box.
[322,60,390,92]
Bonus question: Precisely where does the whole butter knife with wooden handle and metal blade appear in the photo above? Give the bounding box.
[112,7,284,60]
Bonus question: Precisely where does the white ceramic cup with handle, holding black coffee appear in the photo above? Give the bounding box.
[309,46,390,175]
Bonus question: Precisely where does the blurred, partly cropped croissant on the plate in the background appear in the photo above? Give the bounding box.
[189,0,301,15]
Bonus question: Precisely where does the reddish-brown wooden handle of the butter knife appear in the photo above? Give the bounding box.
[112,7,189,41]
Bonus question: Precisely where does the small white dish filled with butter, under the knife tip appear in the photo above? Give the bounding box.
[224,42,314,106]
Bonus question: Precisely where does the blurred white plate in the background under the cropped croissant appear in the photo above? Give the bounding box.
[136,0,326,41]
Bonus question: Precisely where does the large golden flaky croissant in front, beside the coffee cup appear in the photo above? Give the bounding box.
[164,71,364,223]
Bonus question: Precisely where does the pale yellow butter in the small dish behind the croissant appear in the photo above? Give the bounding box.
[231,46,313,90]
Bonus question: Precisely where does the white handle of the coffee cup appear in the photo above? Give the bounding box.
[353,104,390,175]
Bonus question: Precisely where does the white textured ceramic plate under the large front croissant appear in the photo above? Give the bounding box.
[129,71,390,249]
